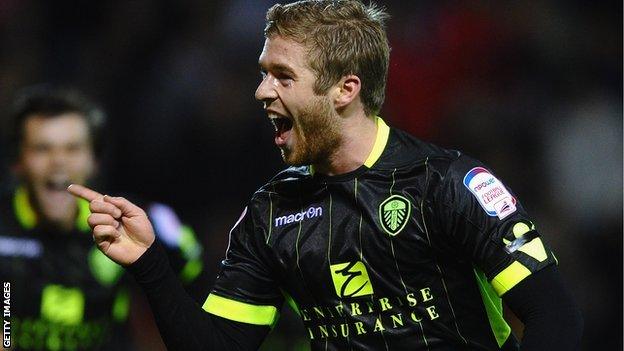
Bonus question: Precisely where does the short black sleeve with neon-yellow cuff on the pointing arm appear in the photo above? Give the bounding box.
[203,208,284,326]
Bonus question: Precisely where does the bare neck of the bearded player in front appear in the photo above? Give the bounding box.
[313,111,377,176]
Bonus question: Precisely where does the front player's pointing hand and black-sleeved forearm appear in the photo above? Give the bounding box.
[68,184,269,351]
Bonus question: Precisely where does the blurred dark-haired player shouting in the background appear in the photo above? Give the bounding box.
[0,86,205,350]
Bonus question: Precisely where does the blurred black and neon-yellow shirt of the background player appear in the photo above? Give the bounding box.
[0,188,205,350]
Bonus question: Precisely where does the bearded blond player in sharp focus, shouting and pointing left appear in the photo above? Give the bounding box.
[69,0,582,351]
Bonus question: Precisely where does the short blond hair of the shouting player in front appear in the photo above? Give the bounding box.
[264,0,390,116]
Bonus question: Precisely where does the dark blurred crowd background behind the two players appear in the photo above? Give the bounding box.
[0,0,622,350]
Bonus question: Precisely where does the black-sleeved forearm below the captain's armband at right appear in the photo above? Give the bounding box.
[503,266,583,351]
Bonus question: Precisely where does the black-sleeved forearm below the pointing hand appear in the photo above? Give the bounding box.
[128,242,269,351]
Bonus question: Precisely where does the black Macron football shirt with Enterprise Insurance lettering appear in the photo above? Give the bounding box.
[204,118,555,350]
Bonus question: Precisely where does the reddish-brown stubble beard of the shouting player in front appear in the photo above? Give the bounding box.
[281,96,342,166]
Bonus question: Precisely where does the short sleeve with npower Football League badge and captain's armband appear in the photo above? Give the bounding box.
[434,156,556,296]
